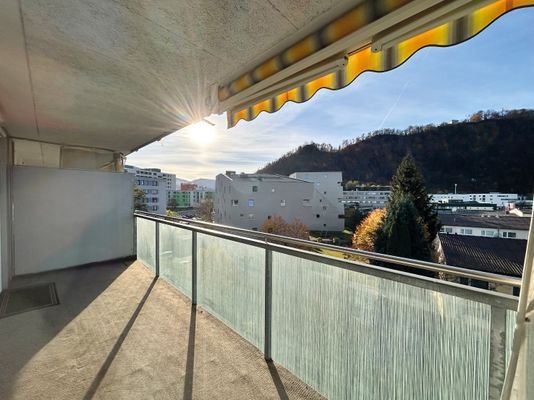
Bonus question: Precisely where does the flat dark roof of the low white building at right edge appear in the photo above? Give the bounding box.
[439,214,530,231]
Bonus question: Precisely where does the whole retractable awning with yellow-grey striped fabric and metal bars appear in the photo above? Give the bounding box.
[218,0,534,127]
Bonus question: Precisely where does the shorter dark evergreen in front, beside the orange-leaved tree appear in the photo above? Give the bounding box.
[375,193,434,276]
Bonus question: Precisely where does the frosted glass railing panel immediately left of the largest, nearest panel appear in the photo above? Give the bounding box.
[197,233,265,349]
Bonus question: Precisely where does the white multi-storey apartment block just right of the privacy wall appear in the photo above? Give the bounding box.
[124,165,176,214]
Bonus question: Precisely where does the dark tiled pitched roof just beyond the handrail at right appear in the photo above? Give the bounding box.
[438,234,527,293]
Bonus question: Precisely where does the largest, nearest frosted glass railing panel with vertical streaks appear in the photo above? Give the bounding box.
[272,253,491,400]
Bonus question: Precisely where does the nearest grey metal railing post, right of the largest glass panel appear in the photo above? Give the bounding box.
[489,305,506,400]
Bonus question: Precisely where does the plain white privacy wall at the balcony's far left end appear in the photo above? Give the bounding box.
[13,166,134,275]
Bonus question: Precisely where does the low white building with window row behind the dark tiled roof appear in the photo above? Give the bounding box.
[439,214,530,240]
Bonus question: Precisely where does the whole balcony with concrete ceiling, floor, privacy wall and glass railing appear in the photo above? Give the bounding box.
[0,0,534,400]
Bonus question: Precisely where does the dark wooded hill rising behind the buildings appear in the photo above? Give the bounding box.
[258,110,534,194]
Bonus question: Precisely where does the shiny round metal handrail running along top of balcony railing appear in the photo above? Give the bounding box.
[134,211,521,287]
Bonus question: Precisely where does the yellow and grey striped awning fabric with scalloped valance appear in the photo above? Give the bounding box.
[222,0,534,128]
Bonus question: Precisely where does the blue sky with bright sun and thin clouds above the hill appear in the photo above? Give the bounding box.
[127,8,534,180]
